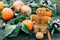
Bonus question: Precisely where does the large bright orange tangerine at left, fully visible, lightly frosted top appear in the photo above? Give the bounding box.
[2,8,14,20]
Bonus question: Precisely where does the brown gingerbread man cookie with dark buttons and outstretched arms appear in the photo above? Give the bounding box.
[30,8,52,40]
